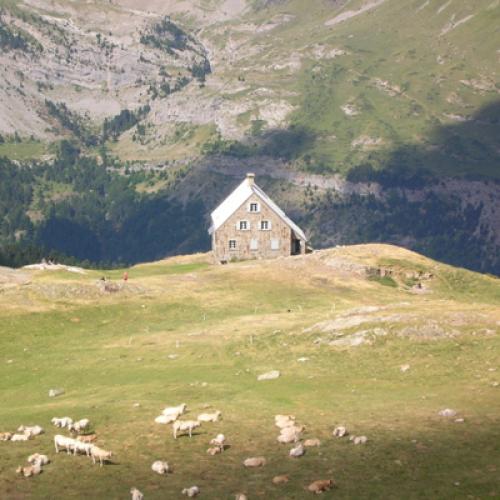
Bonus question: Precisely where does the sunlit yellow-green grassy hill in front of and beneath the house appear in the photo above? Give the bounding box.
[0,245,500,499]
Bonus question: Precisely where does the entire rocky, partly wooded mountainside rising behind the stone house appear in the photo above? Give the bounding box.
[0,0,500,274]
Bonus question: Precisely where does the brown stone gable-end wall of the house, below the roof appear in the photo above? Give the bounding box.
[212,195,292,262]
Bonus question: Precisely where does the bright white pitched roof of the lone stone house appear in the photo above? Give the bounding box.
[209,176,307,241]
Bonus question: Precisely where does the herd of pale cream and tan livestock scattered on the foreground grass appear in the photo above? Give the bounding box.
[0,403,367,500]
